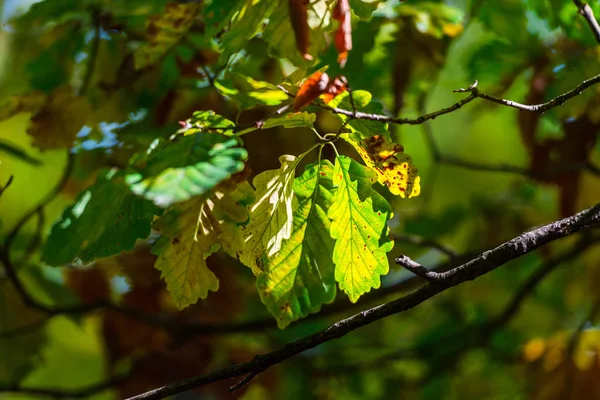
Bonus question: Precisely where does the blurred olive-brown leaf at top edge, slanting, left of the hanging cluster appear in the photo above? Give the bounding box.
[133,2,199,70]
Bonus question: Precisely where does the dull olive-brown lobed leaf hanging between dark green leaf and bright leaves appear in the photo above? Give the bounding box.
[152,182,253,309]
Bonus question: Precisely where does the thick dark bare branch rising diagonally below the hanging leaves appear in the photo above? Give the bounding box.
[129,204,600,400]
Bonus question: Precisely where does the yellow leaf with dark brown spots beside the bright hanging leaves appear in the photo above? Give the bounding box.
[342,134,421,198]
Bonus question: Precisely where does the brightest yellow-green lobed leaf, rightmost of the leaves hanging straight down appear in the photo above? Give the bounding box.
[327,156,394,303]
